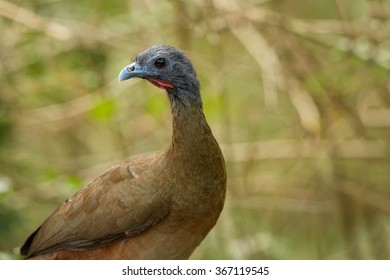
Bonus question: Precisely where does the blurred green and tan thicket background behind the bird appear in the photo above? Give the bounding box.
[0,0,390,259]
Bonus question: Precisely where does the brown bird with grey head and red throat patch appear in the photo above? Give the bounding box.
[20,45,227,260]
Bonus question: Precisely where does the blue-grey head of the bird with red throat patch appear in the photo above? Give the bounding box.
[118,45,201,106]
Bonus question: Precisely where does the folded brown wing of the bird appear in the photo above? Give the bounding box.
[21,155,170,257]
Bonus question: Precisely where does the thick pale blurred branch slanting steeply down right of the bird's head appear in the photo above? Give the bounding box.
[210,0,321,135]
